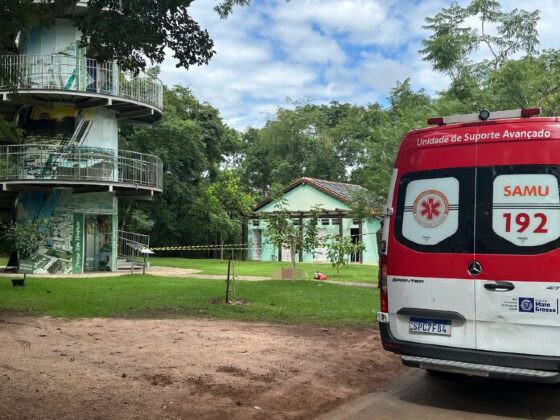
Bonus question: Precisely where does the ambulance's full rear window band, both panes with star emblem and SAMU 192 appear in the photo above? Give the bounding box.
[394,165,560,255]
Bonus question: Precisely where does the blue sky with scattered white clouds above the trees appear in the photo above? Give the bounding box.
[160,0,560,130]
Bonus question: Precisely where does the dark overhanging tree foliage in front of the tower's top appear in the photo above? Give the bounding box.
[0,0,254,72]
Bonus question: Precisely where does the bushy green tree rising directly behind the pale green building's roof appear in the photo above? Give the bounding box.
[241,102,368,195]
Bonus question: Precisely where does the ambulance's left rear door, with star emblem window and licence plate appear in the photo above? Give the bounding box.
[387,127,476,349]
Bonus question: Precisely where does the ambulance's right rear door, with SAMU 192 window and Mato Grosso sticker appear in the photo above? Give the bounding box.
[475,122,560,356]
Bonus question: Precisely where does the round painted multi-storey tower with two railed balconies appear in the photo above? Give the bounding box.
[0,1,163,273]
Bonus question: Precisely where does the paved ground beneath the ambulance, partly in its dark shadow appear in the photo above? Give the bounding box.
[322,368,560,420]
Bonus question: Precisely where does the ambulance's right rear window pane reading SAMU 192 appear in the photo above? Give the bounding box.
[476,165,560,254]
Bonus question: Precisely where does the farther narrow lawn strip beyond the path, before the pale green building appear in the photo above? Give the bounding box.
[150,257,377,283]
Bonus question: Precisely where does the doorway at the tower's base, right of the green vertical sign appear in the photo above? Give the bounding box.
[84,214,113,272]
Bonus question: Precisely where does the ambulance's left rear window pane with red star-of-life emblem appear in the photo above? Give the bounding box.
[395,168,475,253]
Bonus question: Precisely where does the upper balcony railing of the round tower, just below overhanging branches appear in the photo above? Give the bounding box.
[0,54,163,110]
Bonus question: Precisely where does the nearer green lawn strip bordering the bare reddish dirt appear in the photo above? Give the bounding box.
[0,275,378,326]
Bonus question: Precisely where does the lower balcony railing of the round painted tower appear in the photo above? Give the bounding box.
[0,144,163,189]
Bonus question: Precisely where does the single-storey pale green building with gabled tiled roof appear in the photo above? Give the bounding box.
[247,178,380,264]
